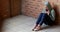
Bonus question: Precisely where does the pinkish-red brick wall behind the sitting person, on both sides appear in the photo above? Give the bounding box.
[22,0,60,24]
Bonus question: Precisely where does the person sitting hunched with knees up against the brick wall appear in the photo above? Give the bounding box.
[32,2,55,31]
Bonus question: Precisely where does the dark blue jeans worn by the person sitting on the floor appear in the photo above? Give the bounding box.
[36,13,54,25]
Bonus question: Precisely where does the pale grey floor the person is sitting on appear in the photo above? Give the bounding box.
[2,15,60,32]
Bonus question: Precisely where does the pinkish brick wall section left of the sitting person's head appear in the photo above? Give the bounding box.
[22,0,44,17]
